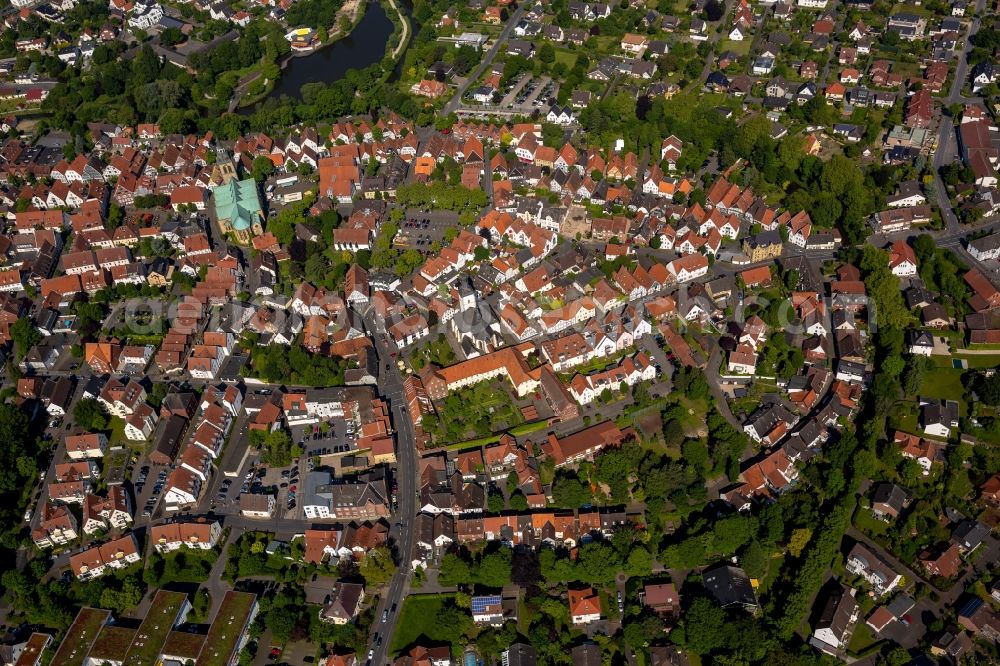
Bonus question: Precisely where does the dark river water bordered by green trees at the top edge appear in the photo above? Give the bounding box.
[254,0,393,104]
